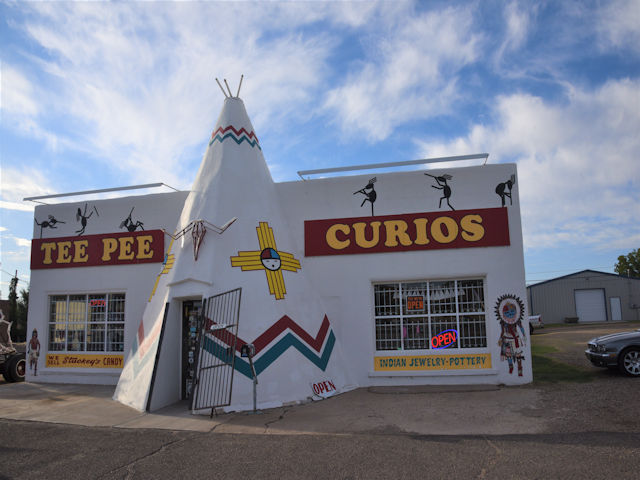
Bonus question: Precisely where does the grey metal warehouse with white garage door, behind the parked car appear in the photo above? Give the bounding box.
[527,270,640,323]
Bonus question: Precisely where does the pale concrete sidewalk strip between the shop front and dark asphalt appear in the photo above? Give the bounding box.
[0,383,547,435]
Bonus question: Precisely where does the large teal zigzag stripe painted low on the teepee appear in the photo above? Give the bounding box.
[203,332,336,379]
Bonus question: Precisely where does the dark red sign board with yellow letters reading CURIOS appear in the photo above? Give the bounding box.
[304,208,510,257]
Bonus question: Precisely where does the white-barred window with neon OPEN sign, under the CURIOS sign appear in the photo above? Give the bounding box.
[373,279,487,351]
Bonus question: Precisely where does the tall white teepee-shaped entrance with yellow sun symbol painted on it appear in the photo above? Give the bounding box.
[114,97,350,410]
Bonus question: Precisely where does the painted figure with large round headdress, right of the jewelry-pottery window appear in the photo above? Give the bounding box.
[495,295,527,377]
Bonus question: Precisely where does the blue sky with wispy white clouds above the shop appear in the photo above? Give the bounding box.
[0,0,640,298]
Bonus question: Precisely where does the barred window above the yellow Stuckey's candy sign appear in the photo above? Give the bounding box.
[49,293,125,352]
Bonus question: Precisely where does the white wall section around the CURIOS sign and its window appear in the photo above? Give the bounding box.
[278,164,532,386]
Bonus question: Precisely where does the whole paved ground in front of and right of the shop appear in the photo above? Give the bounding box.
[0,323,640,479]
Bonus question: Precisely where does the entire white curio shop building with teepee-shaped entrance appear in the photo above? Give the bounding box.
[27,93,532,411]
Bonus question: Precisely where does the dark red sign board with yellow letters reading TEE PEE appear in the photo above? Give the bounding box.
[31,230,164,270]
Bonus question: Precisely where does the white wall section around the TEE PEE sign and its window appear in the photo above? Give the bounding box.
[27,192,188,385]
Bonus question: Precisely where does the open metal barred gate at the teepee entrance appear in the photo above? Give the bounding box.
[191,288,242,415]
